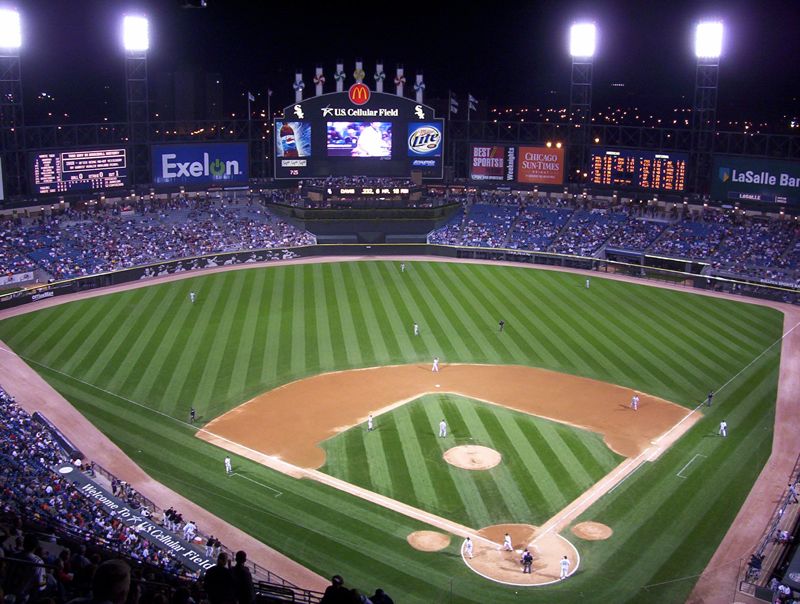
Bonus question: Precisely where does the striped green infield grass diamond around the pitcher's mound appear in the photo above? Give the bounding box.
[321,394,624,528]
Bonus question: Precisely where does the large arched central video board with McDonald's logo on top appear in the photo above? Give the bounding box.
[274,84,445,179]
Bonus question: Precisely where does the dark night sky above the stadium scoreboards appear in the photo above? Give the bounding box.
[12,0,800,122]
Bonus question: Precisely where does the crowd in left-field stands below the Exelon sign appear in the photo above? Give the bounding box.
[0,198,314,279]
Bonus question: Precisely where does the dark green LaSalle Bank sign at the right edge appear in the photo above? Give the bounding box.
[711,155,800,205]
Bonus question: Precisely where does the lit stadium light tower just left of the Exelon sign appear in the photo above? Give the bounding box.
[122,15,150,186]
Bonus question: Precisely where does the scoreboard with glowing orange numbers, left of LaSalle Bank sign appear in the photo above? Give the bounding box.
[591,147,688,192]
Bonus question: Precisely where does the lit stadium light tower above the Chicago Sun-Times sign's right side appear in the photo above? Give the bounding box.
[567,23,597,181]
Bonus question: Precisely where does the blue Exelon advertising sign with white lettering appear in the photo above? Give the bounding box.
[151,143,248,185]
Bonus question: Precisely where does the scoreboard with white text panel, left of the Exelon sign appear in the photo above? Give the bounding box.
[31,148,128,195]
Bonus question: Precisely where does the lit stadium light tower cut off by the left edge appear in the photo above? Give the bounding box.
[0,8,26,196]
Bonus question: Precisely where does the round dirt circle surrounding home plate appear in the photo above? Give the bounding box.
[461,524,580,587]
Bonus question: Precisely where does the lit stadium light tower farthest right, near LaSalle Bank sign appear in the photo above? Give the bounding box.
[689,21,723,193]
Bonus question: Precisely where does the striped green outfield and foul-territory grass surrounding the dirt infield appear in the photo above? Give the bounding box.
[0,261,782,603]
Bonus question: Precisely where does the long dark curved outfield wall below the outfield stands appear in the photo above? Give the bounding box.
[0,243,800,310]
